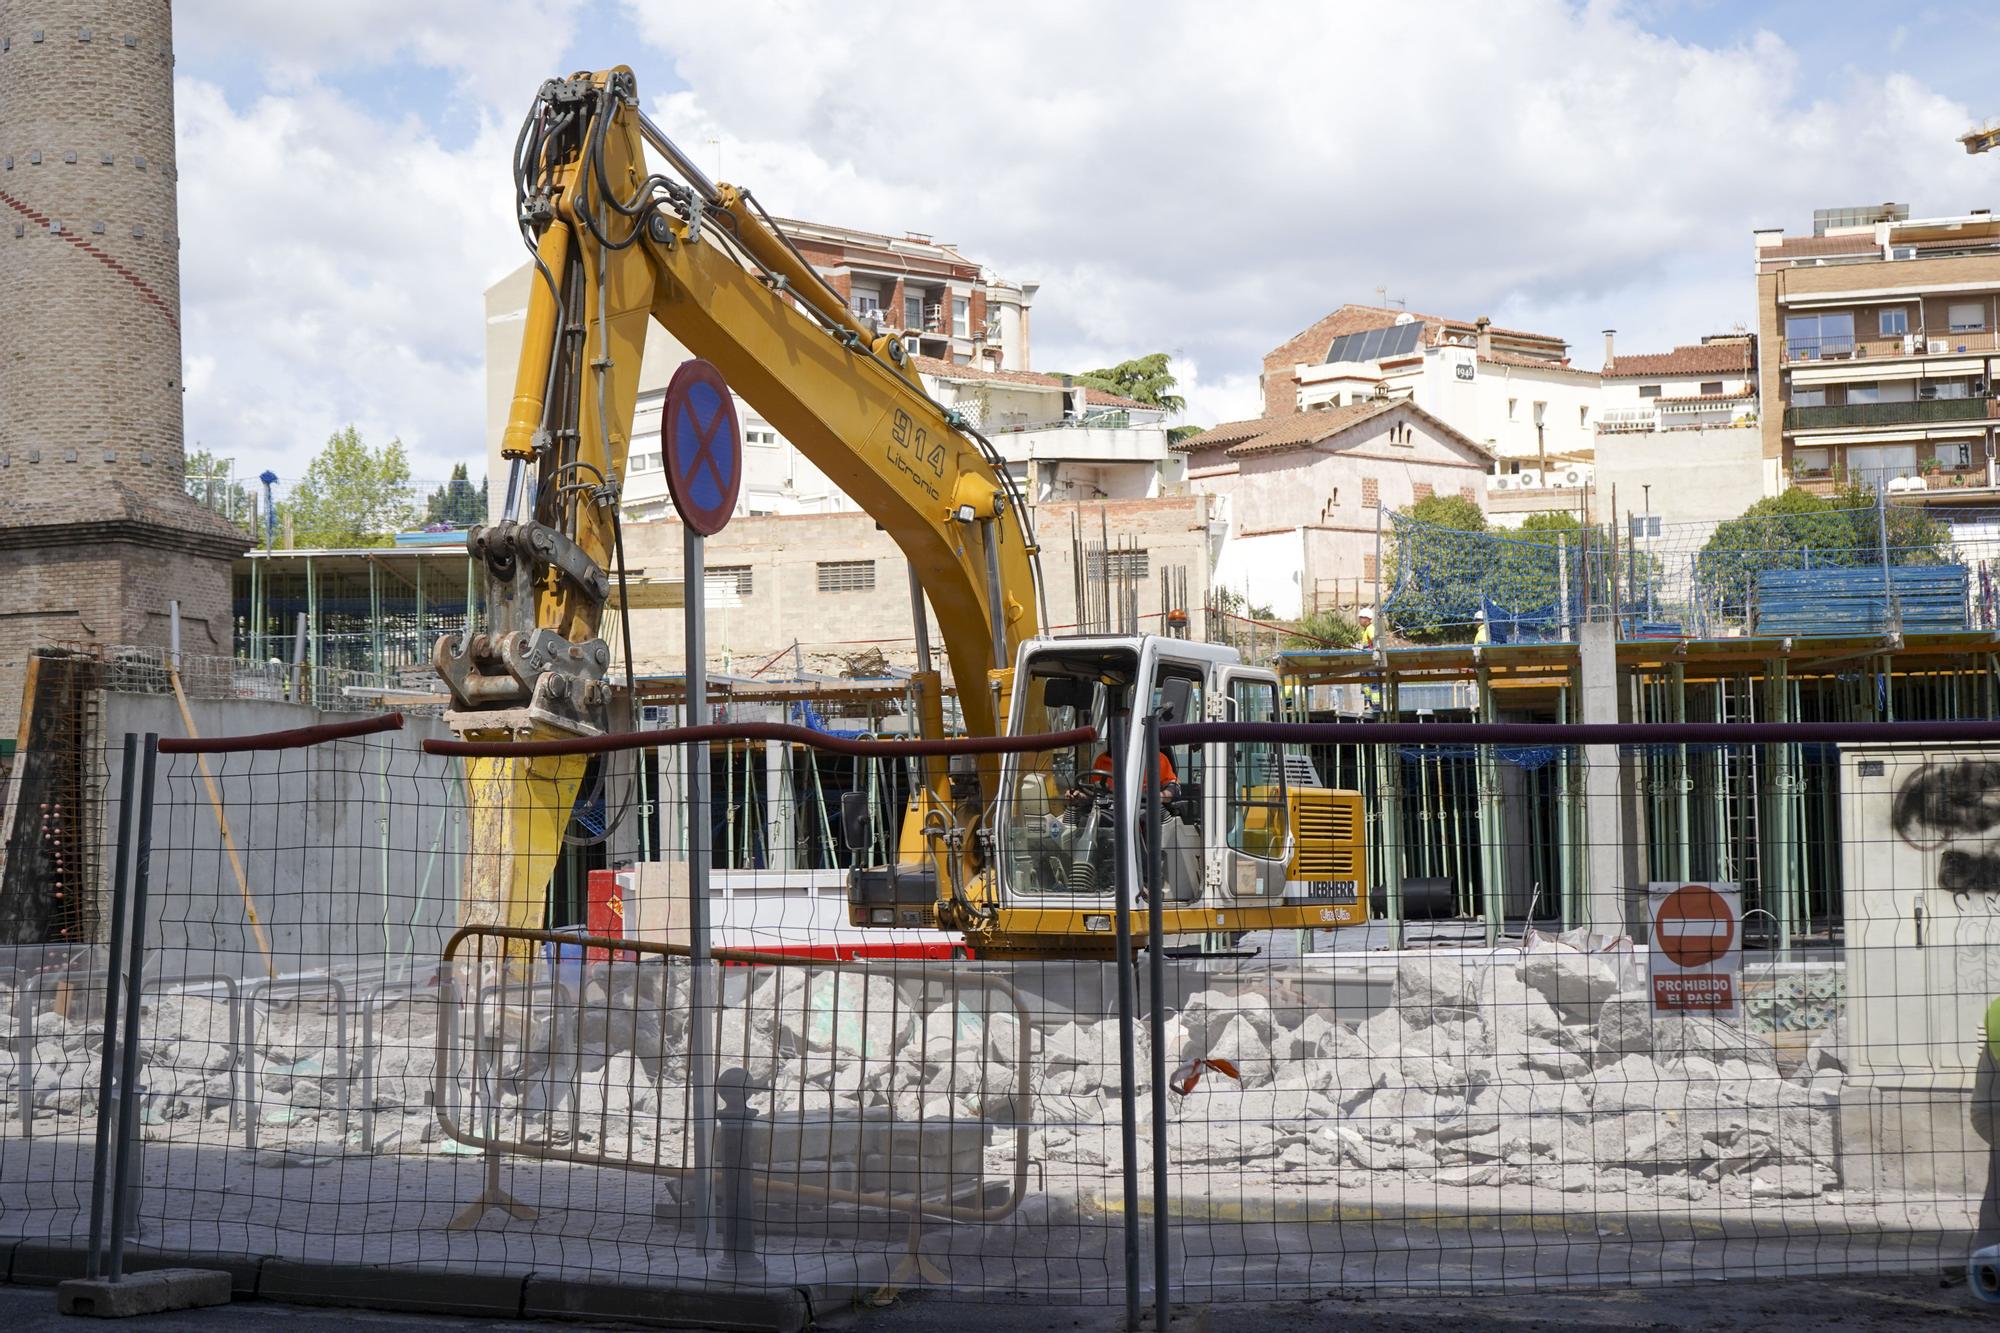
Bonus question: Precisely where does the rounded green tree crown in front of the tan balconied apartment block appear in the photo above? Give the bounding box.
[1694,486,1950,608]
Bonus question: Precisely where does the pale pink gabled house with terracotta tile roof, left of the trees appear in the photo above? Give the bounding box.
[1178,398,1494,616]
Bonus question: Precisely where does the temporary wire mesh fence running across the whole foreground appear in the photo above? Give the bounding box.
[0,725,2000,1305]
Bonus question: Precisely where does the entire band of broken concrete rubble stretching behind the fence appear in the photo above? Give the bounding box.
[0,939,1842,1201]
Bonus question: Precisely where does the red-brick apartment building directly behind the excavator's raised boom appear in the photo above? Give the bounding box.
[776,218,1038,370]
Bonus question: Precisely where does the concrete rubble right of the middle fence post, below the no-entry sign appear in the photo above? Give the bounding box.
[1172,928,1842,1201]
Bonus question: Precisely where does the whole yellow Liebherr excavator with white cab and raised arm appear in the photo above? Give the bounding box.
[434,66,1368,957]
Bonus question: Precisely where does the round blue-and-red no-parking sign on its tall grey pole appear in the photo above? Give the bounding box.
[660,360,742,1249]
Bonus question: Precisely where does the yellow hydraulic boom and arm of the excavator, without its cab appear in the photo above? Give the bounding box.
[434,66,1040,925]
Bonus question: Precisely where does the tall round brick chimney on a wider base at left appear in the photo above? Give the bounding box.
[0,0,250,735]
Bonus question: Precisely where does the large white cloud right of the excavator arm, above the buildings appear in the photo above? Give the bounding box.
[626,0,1988,418]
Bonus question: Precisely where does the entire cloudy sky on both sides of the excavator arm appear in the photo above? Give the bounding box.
[174,0,2000,488]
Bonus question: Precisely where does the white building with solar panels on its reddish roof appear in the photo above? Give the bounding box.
[1262,304,1600,466]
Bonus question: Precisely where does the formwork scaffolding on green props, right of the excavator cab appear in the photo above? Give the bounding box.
[1280,630,2000,949]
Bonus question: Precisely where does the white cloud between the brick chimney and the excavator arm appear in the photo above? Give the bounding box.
[176,78,520,478]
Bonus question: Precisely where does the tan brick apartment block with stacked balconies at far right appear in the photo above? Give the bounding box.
[1754,204,2000,498]
